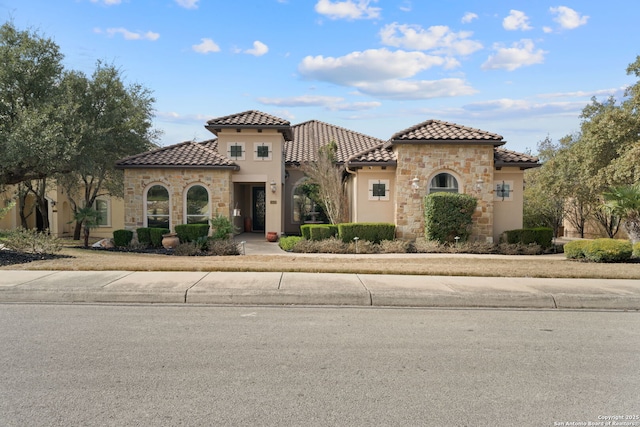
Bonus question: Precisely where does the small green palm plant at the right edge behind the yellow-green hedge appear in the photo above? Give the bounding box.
[604,182,640,245]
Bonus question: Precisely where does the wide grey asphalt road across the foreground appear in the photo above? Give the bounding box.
[0,304,640,426]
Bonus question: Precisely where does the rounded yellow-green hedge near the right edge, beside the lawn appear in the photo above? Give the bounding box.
[564,239,633,262]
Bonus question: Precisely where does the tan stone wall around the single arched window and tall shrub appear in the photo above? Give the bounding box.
[394,144,494,242]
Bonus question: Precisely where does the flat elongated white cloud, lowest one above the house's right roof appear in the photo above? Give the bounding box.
[355,78,477,100]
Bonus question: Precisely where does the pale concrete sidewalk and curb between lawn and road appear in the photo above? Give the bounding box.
[0,270,640,310]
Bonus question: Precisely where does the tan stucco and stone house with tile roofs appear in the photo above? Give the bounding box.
[116,111,539,242]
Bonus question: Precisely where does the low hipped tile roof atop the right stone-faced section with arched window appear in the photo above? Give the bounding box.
[390,120,504,145]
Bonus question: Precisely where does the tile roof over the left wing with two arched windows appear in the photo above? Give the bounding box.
[116,140,238,169]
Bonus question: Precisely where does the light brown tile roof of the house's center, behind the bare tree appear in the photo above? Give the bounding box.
[285,120,384,164]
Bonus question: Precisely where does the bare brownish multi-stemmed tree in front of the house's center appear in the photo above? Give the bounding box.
[302,141,348,224]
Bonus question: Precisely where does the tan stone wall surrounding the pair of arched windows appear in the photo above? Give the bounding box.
[124,168,232,231]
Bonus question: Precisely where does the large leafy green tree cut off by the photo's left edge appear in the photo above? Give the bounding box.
[0,23,74,185]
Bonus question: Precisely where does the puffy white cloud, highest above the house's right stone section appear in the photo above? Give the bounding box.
[380,22,482,55]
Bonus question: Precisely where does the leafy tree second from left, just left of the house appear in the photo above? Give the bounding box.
[57,63,158,239]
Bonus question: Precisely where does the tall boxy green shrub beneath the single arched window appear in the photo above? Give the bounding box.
[424,192,478,243]
